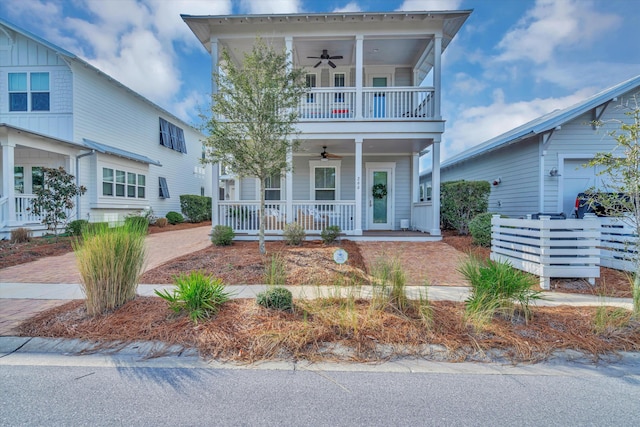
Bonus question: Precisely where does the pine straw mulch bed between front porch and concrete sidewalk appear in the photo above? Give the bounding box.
[140,240,368,285]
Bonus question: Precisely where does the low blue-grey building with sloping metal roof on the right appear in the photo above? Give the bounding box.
[420,76,640,218]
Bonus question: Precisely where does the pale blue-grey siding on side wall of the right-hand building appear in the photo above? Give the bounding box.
[440,137,539,217]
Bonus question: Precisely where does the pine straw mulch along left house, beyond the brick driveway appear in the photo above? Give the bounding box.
[0,221,211,268]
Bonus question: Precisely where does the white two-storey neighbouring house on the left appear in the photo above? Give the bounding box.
[0,19,211,238]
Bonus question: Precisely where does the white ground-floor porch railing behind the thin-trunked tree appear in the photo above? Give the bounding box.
[218,200,355,234]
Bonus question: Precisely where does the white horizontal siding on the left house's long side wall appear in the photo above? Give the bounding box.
[73,64,211,216]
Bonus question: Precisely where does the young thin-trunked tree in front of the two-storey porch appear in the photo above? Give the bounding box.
[204,39,307,254]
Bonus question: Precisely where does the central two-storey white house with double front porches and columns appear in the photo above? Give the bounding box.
[182,11,471,240]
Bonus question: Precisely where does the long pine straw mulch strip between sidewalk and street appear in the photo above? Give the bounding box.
[20,297,640,363]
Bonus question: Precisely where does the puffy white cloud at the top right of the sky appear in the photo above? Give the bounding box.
[497,0,621,64]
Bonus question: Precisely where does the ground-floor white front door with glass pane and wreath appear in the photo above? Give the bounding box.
[367,166,393,230]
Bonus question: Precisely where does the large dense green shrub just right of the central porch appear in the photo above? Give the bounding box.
[440,180,491,234]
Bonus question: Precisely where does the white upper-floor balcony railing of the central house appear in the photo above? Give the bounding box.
[298,86,435,121]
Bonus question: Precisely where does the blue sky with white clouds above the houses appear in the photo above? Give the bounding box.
[0,0,640,166]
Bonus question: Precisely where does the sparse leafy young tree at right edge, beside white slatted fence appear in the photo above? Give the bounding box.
[587,94,640,316]
